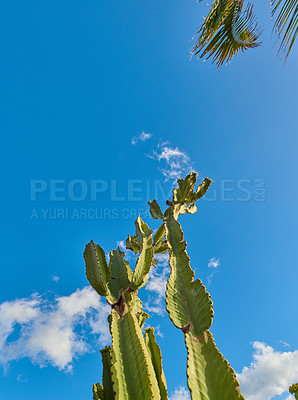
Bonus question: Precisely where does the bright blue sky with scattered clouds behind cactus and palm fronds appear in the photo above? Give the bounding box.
[0,0,298,400]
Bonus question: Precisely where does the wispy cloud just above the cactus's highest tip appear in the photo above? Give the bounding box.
[148,142,194,181]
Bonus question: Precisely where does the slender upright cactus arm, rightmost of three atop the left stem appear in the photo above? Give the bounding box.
[130,217,153,290]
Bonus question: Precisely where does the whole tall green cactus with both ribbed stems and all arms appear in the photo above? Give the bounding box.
[84,173,244,400]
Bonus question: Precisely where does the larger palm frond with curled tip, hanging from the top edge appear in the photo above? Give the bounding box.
[193,0,261,68]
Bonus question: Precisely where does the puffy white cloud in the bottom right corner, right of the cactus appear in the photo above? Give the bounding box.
[237,342,298,400]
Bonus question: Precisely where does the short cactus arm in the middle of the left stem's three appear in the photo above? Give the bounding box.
[109,248,132,299]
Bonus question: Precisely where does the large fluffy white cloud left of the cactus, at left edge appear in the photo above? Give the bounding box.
[0,287,110,370]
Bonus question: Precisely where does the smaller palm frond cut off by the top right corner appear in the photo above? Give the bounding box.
[272,0,298,59]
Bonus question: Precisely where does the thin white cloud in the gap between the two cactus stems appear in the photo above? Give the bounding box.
[144,254,170,315]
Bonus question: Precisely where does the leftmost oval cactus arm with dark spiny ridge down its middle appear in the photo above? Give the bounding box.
[84,240,111,296]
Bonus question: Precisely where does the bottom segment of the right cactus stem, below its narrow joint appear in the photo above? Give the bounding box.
[184,331,244,400]
